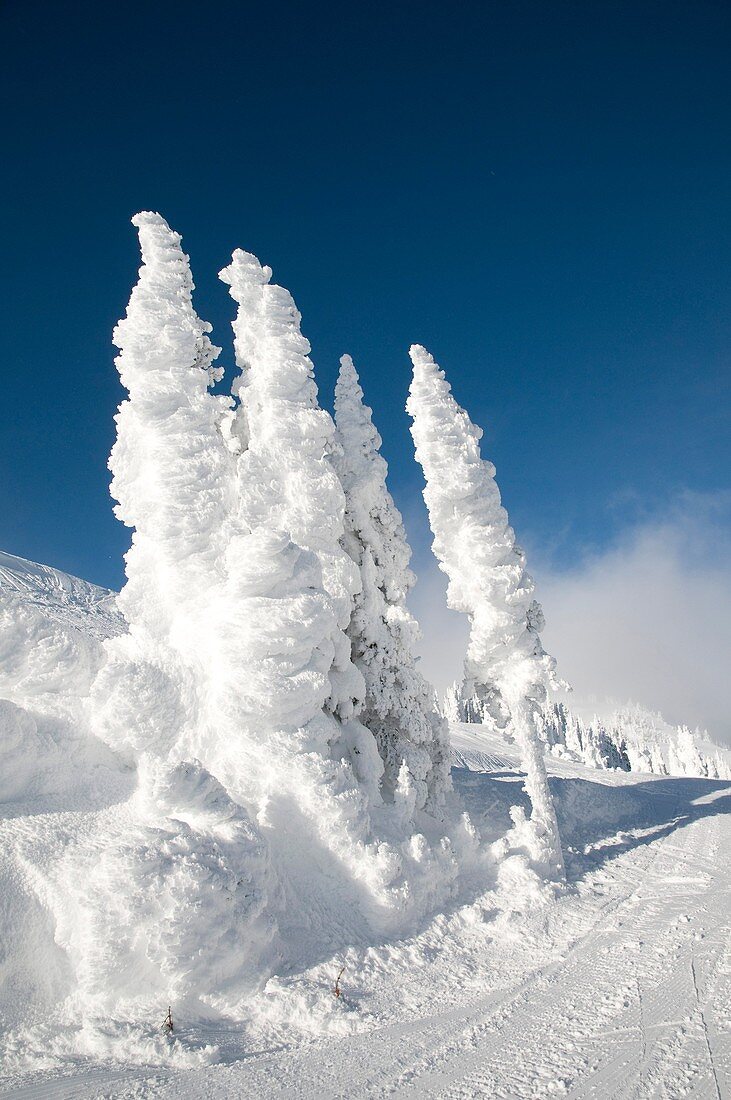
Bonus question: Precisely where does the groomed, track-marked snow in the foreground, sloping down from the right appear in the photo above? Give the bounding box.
[0,726,731,1100]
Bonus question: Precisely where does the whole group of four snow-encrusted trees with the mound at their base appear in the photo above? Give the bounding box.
[68,213,563,1018]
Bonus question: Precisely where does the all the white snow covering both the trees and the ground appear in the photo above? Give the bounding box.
[0,213,731,1100]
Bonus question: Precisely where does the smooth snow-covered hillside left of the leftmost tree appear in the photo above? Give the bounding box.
[0,553,131,1051]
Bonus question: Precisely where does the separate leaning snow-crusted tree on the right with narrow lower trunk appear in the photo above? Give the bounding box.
[407,344,564,879]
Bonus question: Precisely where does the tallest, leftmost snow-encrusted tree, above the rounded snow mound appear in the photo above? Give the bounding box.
[89,213,235,758]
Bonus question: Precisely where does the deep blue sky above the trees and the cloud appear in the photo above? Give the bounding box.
[0,0,731,585]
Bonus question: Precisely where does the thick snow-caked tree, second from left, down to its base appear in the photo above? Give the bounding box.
[217,250,454,928]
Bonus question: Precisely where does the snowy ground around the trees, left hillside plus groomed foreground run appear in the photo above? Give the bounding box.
[0,556,731,1100]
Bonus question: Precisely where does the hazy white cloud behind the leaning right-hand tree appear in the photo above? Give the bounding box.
[412,493,731,743]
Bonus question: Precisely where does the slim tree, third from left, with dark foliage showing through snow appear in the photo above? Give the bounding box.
[335,355,451,811]
